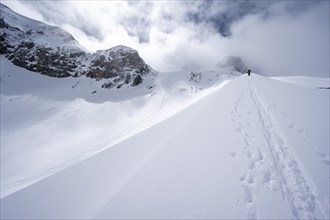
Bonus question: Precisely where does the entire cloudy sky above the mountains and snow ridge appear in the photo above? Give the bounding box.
[1,0,330,77]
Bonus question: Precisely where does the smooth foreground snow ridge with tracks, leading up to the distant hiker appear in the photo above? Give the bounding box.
[1,74,330,219]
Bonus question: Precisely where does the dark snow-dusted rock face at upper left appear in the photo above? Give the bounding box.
[0,4,156,88]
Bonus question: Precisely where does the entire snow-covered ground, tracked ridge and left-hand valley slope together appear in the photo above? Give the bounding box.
[1,57,330,219]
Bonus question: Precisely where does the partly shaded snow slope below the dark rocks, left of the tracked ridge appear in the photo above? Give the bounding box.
[0,54,231,198]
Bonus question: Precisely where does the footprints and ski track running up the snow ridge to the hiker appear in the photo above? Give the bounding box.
[232,79,318,219]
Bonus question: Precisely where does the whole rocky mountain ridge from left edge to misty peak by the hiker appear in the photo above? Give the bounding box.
[0,3,247,93]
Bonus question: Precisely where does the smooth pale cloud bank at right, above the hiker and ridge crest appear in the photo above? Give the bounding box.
[232,3,329,76]
